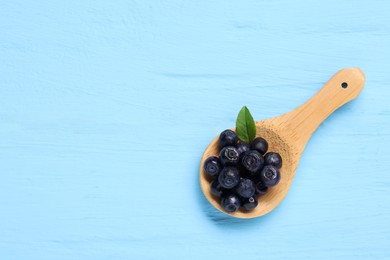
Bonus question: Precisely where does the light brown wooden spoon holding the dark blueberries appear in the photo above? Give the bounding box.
[200,68,365,218]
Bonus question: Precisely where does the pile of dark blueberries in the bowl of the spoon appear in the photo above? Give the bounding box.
[203,130,282,213]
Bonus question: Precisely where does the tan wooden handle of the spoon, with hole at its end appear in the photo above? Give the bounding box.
[275,68,365,150]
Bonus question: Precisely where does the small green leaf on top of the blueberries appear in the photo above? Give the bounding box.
[236,106,256,143]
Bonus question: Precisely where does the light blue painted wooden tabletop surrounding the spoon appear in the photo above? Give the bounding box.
[0,0,390,260]
